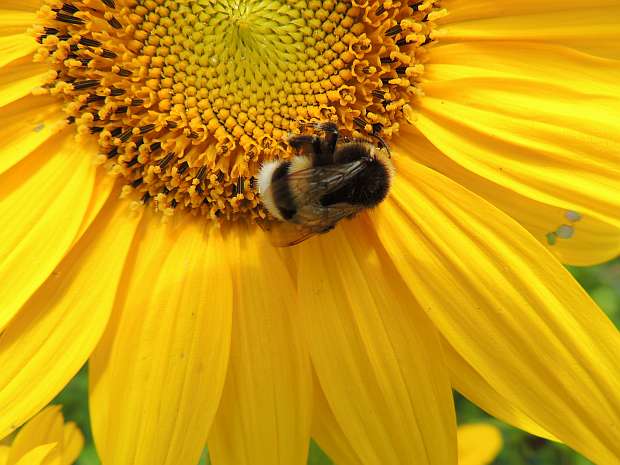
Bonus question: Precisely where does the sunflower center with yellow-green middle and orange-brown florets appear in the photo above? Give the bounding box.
[37,0,444,219]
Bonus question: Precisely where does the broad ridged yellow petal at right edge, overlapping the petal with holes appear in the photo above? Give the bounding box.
[414,42,620,228]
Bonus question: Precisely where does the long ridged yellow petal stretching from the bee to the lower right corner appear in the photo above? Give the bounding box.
[375,159,620,463]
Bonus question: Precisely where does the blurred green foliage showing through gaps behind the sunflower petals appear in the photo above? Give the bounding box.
[54,259,620,465]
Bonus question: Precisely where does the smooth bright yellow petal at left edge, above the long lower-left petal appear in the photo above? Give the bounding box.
[0,129,95,330]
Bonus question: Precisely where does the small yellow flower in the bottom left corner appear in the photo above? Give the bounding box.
[0,405,83,465]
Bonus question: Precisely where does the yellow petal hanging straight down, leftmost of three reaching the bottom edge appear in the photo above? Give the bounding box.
[90,212,232,465]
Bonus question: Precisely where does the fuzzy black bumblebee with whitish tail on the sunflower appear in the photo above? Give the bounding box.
[258,122,394,247]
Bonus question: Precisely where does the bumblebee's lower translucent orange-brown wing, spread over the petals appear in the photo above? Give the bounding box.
[264,203,362,247]
